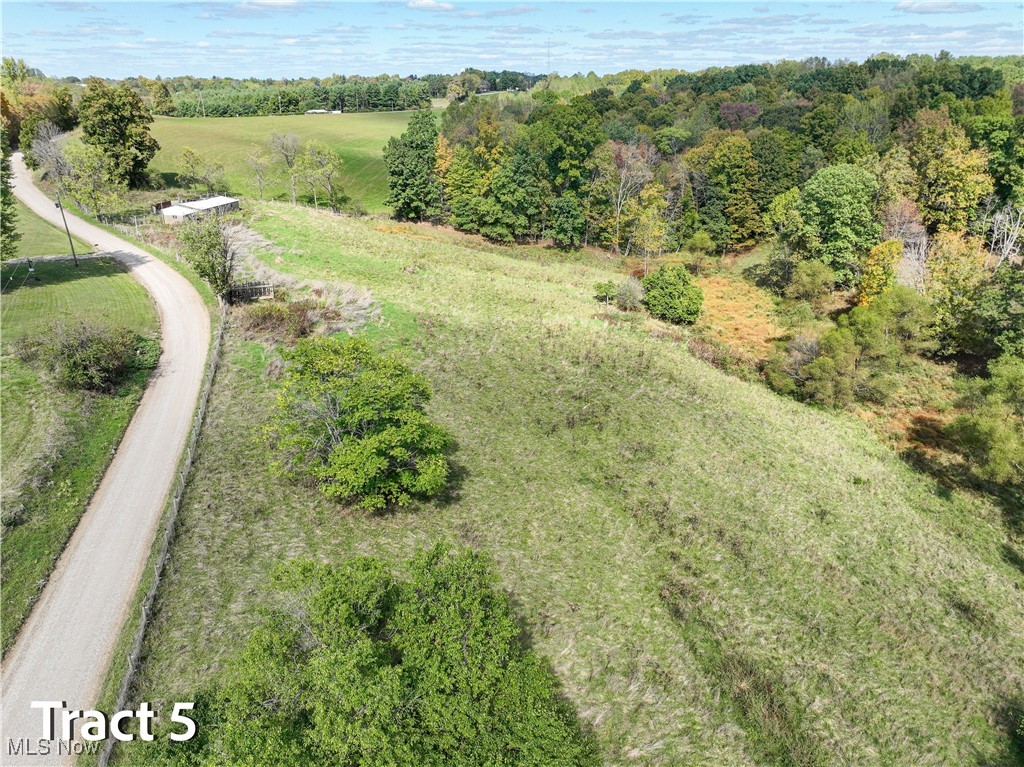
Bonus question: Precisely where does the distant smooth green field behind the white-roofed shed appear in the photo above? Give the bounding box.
[151,112,421,213]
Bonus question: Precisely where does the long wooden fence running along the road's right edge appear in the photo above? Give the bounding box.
[96,304,227,767]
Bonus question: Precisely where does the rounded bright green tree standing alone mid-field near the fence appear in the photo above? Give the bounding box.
[266,337,452,510]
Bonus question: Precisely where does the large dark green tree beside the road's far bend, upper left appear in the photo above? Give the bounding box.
[79,79,160,187]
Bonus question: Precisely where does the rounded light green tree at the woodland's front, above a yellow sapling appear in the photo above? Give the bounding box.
[796,165,882,285]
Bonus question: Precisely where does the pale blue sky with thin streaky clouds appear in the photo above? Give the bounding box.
[0,0,1024,78]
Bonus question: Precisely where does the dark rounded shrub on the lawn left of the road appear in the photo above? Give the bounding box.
[17,323,154,391]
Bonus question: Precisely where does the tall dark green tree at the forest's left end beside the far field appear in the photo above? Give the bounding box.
[384,111,441,221]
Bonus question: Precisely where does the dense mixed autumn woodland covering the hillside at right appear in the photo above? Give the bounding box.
[385,53,1024,480]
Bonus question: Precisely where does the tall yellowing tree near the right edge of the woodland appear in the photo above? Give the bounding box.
[910,105,992,233]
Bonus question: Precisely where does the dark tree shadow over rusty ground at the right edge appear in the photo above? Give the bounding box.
[900,414,1024,535]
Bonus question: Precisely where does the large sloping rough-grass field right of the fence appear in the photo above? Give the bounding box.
[118,205,1024,767]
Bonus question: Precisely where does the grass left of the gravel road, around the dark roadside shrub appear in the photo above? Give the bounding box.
[0,258,158,650]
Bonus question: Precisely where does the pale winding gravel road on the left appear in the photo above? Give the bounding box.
[0,154,210,767]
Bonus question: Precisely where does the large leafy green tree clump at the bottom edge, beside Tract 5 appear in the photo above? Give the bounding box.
[140,545,597,767]
